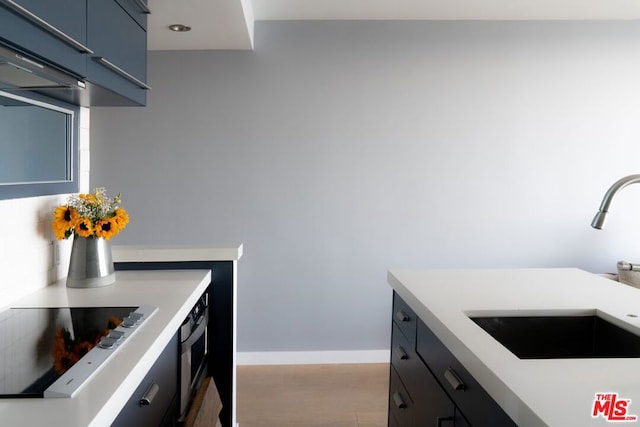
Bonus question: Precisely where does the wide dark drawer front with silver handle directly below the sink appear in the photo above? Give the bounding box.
[417,321,516,427]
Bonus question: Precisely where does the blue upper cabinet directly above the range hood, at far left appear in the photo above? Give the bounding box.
[0,0,91,78]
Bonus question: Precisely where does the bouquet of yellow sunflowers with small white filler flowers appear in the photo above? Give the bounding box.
[51,188,129,240]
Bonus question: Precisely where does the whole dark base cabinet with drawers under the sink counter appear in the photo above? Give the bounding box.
[389,292,516,427]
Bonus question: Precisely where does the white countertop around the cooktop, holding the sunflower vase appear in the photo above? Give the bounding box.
[0,270,211,427]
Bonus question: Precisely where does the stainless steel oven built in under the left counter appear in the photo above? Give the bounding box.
[179,293,209,421]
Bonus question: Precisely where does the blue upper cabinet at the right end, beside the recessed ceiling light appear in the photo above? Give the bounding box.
[87,0,149,105]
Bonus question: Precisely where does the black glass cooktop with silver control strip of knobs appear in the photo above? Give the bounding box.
[0,306,157,398]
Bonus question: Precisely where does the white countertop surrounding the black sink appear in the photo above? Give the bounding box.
[388,269,640,427]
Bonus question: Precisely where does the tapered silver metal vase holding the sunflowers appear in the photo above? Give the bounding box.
[67,234,116,288]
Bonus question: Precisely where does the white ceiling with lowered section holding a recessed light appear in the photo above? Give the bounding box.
[148,0,640,50]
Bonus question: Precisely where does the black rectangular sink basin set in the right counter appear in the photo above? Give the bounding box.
[470,314,640,359]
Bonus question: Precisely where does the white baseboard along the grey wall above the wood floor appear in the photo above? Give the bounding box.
[236,350,391,365]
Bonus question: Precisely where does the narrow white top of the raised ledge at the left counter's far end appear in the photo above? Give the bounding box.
[111,243,243,262]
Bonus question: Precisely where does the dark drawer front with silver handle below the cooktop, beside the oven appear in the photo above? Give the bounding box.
[112,334,178,427]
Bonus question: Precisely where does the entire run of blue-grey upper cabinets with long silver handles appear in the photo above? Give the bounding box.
[0,0,149,106]
